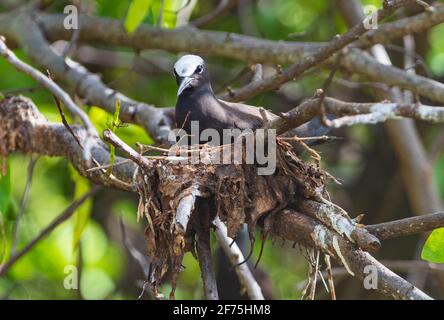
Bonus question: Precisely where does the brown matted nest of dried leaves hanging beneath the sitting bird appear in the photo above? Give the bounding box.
[137,139,329,295]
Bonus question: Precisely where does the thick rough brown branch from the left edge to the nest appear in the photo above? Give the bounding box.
[0,97,135,190]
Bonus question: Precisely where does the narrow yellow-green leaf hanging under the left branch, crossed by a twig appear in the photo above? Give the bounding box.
[70,166,92,251]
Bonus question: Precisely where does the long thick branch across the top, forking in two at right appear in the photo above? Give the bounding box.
[20,5,444,103]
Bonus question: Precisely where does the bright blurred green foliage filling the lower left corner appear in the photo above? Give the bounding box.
[0,154,126,299]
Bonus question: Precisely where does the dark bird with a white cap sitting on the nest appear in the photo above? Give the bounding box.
[174,55,329,143]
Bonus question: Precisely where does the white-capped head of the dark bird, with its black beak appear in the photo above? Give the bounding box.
[174,54,209,96]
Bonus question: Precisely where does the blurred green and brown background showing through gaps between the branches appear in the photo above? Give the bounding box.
[0,0,444,299]
